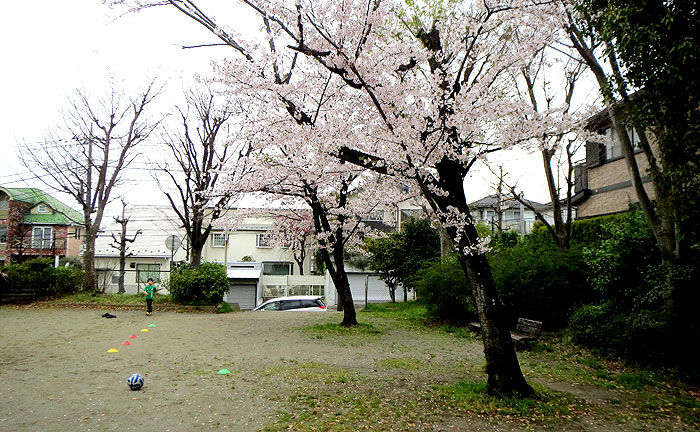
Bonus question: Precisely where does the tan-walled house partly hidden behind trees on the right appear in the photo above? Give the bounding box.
[573,110,654,218]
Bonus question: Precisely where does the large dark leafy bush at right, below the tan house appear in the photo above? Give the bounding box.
[569,211,678,363]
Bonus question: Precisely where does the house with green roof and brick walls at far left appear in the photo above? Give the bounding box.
[0,186,85,263]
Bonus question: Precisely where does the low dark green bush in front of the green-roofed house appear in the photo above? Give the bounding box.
[2,258,85,296]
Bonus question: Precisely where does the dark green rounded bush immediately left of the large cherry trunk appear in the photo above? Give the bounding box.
[413,254,476,324]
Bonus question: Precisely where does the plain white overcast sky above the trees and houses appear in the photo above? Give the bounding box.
[0,0,600,216]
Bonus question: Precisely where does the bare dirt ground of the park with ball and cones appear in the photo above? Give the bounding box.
[0,308,696,431]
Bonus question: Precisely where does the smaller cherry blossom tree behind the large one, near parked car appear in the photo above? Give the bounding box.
[224,98,397,326]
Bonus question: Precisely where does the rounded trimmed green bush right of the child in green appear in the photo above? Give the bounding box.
[169,262,229,305]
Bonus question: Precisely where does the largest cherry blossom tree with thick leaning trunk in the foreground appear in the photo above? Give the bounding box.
[115,0,556,395]
